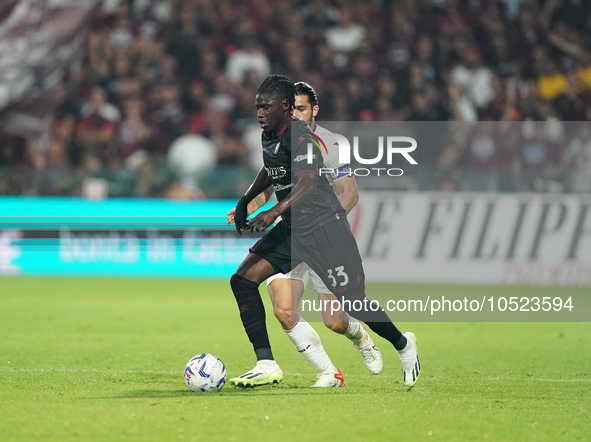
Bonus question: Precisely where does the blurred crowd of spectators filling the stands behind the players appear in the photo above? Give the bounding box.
[0,0,591,198]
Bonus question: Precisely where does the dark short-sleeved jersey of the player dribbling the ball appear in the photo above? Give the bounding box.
[262,117,346,233]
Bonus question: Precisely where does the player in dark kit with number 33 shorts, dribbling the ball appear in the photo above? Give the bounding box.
[229,75,420,387]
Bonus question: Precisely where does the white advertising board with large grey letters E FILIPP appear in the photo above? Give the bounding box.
[349,192,591,287]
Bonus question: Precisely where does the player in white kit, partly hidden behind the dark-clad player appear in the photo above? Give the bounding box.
[228,82,382,388]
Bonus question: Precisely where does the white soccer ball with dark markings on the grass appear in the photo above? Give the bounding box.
[184,353,227,391]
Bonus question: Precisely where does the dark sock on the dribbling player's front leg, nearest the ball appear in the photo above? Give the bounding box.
[230,275,273,361]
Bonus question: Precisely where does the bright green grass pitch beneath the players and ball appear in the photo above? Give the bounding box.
[0,278,591,442]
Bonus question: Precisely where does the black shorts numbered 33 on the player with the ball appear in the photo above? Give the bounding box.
[250,219,365,300]
